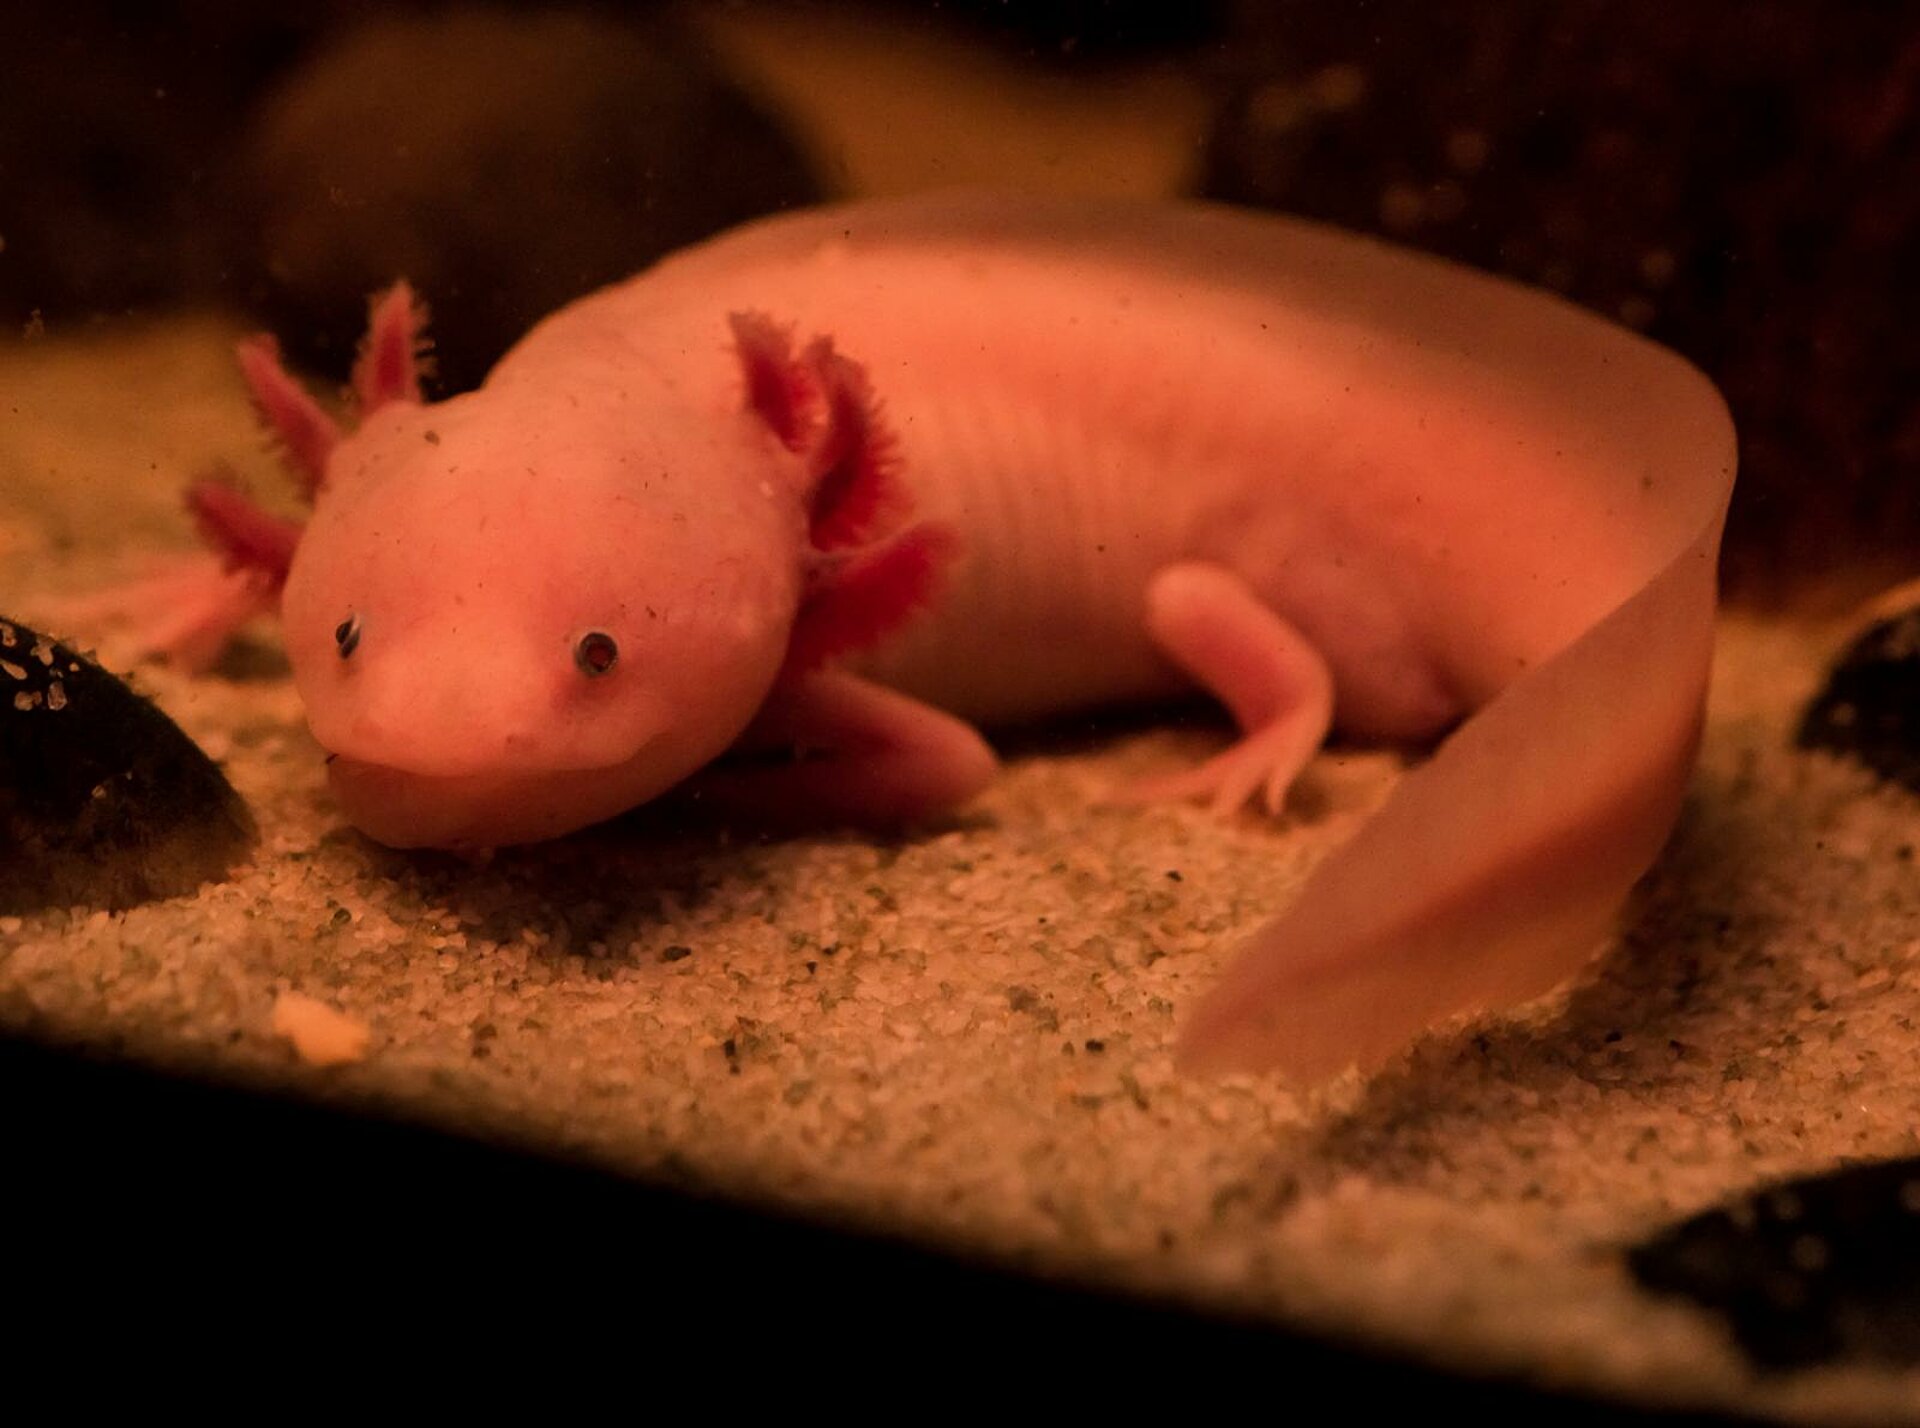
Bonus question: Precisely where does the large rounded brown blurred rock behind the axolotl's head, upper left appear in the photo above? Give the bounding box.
[236,10,822,392]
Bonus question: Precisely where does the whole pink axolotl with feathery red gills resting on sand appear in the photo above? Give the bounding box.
[97,196,1734,1077]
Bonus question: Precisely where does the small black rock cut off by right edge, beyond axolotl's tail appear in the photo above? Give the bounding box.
[1795,607,1920,793]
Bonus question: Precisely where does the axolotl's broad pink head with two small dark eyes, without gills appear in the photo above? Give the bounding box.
[282,390,803,848]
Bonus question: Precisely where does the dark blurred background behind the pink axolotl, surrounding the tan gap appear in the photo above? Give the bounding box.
[0,0,1920,605]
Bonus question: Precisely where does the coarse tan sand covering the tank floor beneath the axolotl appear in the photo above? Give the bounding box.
[11,307,1920,1418]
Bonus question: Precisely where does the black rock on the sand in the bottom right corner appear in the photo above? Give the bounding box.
[1628,1159,1920,1369]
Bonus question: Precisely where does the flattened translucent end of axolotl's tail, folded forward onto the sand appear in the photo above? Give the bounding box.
[1181,516,1720,1081]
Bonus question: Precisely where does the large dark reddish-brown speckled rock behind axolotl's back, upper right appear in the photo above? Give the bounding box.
[1202,0,1920,603]
